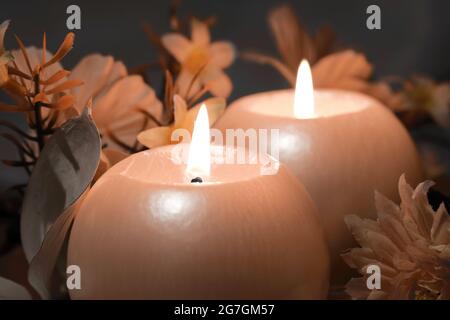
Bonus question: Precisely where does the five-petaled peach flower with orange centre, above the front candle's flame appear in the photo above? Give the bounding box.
[162,19,235,99]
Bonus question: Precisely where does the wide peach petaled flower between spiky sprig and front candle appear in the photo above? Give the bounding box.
[69,54,162,151]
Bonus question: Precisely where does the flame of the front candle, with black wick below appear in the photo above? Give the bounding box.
[186,104,211,178]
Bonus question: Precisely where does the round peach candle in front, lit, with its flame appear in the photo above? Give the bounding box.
[68,107,329,299]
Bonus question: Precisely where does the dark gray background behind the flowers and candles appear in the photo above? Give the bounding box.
[0,0,450,189]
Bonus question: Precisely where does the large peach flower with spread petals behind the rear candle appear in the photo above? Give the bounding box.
[243,5,398,108]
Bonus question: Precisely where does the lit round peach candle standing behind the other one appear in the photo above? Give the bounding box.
[215,61,422,283]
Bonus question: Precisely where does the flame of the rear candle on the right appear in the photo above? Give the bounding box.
[294,59,314,119]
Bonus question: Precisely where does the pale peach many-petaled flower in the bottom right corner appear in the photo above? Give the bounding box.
[342,175,450,299]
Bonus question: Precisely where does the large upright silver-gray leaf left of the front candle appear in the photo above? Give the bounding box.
[20,108,101,262]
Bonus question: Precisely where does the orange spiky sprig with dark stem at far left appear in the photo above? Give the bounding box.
[0,22,82,173]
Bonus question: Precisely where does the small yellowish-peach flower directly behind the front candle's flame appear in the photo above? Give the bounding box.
[138,95,225,148]
